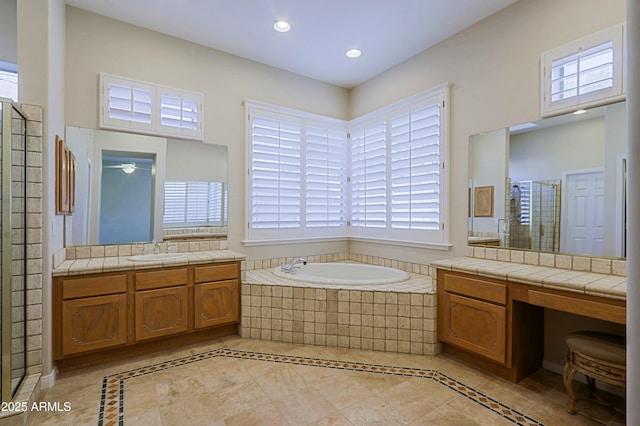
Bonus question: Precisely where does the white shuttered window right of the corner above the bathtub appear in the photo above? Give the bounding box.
[351,86,447,244]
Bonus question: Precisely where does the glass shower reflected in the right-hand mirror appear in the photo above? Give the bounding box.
[505,180,561,251]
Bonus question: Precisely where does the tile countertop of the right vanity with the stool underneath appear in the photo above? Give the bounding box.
[431,257,627,300]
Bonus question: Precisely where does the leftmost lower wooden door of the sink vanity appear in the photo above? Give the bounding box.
[62,294,127,355]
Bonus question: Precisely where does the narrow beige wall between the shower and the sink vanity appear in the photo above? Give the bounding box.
[17,0,65,387]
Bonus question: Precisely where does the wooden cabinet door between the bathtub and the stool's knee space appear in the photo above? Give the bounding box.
[438,292,507,364]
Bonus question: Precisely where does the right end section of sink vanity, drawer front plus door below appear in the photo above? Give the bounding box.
[194,264,240,328]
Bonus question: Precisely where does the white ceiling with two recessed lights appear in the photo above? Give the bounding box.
[66,0,516,88]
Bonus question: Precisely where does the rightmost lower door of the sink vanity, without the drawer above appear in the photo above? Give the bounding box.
[194,280,240,328]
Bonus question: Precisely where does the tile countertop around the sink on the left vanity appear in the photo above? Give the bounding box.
[52,250,247,277]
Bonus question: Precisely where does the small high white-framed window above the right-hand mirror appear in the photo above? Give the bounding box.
[541,24,624,116]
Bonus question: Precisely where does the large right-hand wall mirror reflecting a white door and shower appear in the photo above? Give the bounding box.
[468,102,626,258]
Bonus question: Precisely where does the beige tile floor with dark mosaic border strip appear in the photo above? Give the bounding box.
[29,337,625,426]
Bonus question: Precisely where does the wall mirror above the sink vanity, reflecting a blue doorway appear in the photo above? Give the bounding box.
[65,126,227,247]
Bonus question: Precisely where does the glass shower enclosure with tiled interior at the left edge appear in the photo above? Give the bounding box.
[0,99,27,402]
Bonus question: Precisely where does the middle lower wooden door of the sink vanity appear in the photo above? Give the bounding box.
[136,286,189,341]
